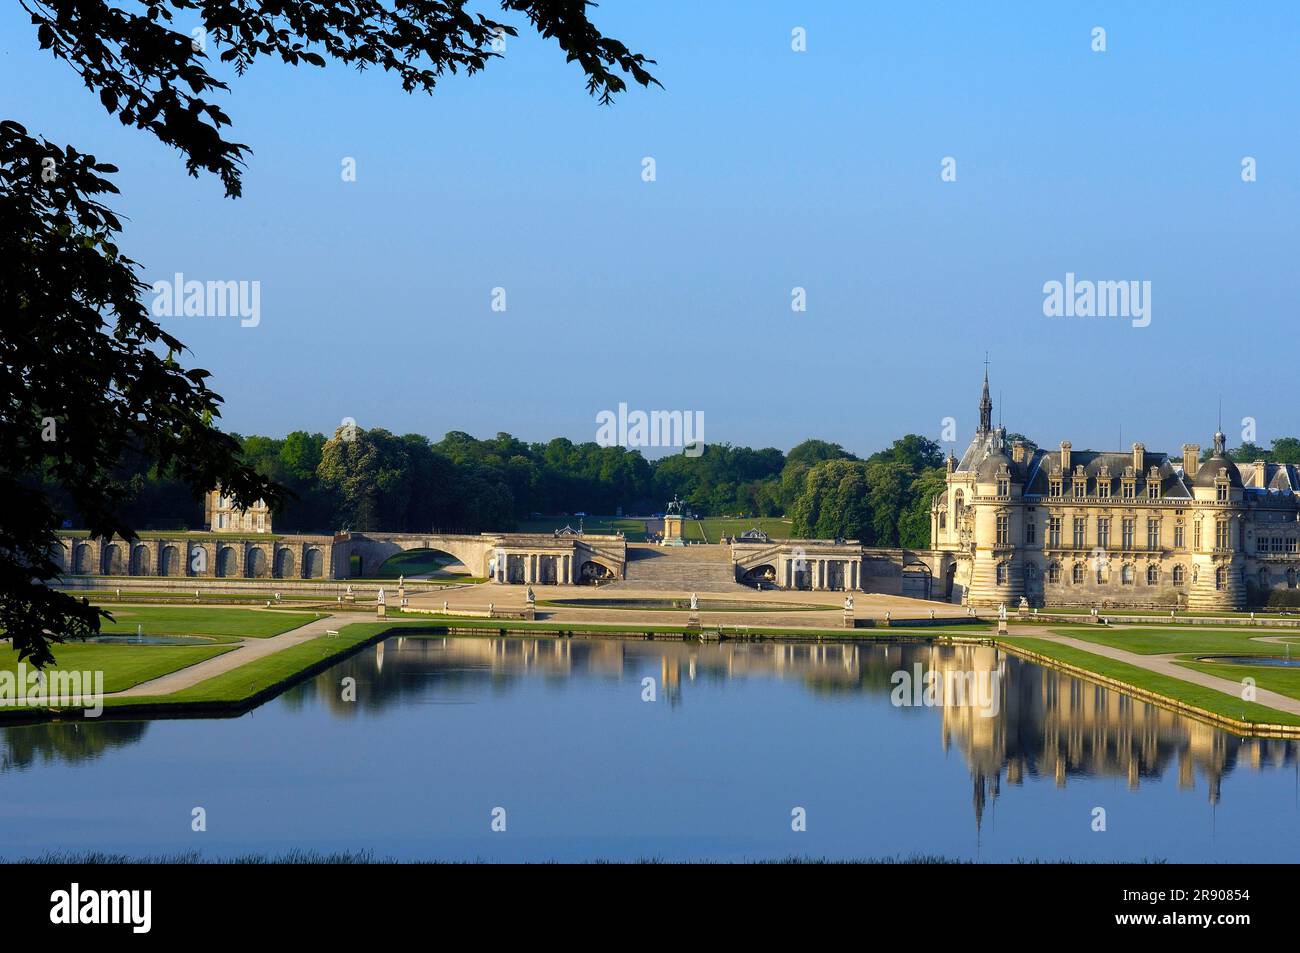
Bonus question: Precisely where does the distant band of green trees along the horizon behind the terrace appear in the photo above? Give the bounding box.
[51,429,1300,547]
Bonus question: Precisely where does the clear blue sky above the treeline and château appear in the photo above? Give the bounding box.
[0,0,1300,452]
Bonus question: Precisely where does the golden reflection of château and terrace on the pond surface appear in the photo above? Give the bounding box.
[327,636,1297,820]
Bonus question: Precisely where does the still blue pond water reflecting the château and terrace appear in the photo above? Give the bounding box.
[0,636,1300,862]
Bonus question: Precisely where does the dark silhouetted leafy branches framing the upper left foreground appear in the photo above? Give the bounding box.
[0,0,658,666]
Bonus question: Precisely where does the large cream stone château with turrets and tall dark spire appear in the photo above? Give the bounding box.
[931,372,1300,610]
